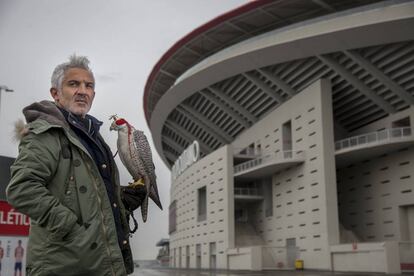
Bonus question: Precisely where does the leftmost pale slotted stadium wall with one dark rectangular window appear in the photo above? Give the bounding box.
[170,146,234,269]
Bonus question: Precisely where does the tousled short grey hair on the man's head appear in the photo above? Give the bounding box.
[51,54,94,90]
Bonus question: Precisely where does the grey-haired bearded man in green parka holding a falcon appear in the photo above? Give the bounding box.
[7,55,133,276]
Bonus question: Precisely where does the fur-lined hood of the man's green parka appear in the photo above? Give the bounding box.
[14,101,69,141]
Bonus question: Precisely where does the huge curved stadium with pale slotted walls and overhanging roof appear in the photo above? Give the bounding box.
[144,0,414,273]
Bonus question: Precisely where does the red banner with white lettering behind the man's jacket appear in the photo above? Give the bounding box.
[0,201,30,236]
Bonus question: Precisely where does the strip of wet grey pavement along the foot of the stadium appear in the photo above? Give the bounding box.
[132,268,402,276]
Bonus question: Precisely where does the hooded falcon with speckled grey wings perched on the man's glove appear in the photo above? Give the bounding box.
[110,115,162,222]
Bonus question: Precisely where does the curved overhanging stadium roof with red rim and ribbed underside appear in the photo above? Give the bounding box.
[144,0,414,166]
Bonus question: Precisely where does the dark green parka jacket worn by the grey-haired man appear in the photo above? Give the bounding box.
[6,101,133,276]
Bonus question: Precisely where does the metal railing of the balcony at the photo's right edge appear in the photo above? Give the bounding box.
[335,127,412,151]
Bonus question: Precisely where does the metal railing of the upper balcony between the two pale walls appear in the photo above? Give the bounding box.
[234,151,304,174]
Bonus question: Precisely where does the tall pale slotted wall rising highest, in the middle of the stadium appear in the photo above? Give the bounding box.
[233,80,339,269]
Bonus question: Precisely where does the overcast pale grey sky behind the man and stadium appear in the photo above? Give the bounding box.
[0,0,248,259]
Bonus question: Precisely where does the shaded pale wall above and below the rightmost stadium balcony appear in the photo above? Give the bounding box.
[337,106,414,242]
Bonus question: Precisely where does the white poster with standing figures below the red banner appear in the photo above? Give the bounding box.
[0,236,28,276]
